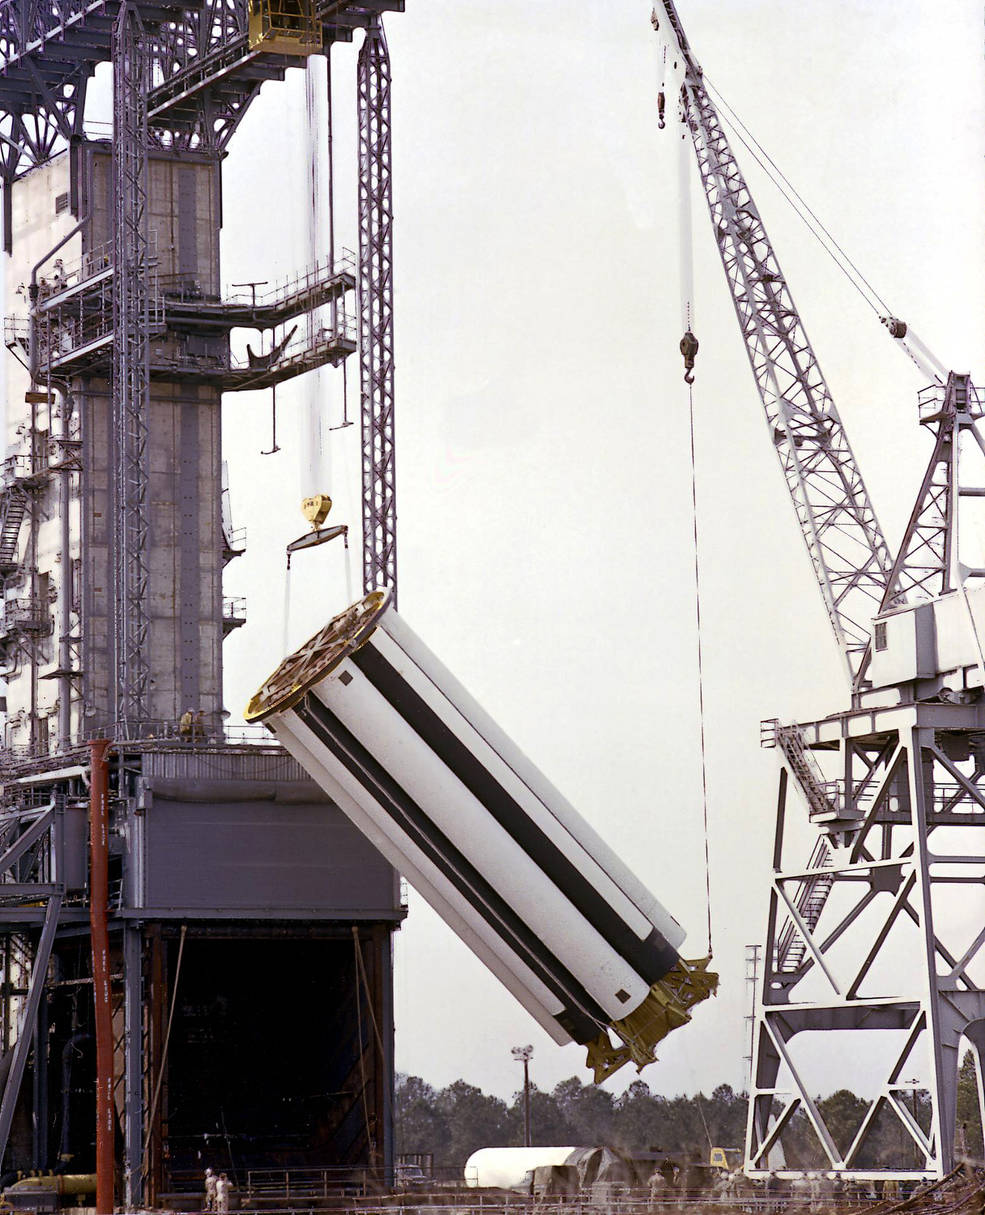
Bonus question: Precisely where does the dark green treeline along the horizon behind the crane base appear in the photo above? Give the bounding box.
[395,1052,983,1169]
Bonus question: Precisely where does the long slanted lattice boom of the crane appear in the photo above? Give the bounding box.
[652,0,893,686]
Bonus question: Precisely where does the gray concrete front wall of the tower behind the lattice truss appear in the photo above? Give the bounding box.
[81,146,223,734]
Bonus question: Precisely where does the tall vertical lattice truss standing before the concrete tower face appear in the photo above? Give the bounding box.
[113,0,151,738]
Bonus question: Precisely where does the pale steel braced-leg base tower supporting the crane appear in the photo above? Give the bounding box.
[746,705,985,1180]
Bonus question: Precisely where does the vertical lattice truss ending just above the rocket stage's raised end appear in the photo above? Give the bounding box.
[358,18,397,603]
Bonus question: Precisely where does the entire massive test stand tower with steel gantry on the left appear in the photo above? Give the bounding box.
[0,0,403,1210]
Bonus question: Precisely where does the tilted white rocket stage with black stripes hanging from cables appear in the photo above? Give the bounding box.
[247,590,718,1081]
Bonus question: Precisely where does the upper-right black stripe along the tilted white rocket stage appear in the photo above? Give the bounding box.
[351,643,678,984]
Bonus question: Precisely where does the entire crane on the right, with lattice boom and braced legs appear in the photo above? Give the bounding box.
[652,0,985,1180]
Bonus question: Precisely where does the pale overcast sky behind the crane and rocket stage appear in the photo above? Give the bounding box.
[216,0,985,1096]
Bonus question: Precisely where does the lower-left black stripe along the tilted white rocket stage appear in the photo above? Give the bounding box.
[294,694,599,1045]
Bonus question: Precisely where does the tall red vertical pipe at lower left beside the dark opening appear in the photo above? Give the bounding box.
[89,739,117,1215]
